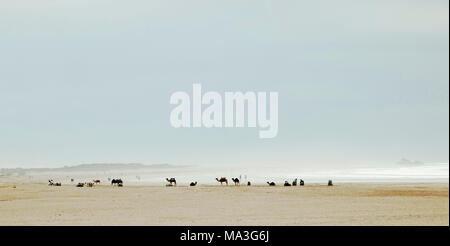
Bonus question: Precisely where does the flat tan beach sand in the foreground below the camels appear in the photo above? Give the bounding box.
[0,182,449,226]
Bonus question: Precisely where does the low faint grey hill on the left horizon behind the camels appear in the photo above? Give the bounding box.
[0,163,179,175]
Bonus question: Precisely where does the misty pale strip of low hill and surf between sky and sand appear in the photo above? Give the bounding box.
[0,163,449,185]
